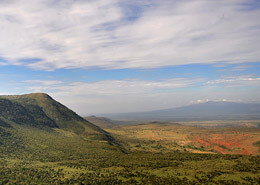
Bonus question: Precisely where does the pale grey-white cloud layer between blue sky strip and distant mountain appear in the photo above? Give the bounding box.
[17,78,260,115]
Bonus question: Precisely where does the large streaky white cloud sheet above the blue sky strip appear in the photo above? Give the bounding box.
[0,0,260,70]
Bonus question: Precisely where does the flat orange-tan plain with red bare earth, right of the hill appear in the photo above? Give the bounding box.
[106,122,260,155]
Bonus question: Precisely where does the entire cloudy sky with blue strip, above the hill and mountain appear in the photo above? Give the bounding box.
[0,0,260,115]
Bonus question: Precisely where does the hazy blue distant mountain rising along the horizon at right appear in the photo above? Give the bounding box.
[99,101,260,121]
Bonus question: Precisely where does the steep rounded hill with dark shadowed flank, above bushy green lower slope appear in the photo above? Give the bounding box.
[0,93,113,141]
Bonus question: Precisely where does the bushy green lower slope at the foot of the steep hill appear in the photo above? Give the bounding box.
[0,122,120,162]
